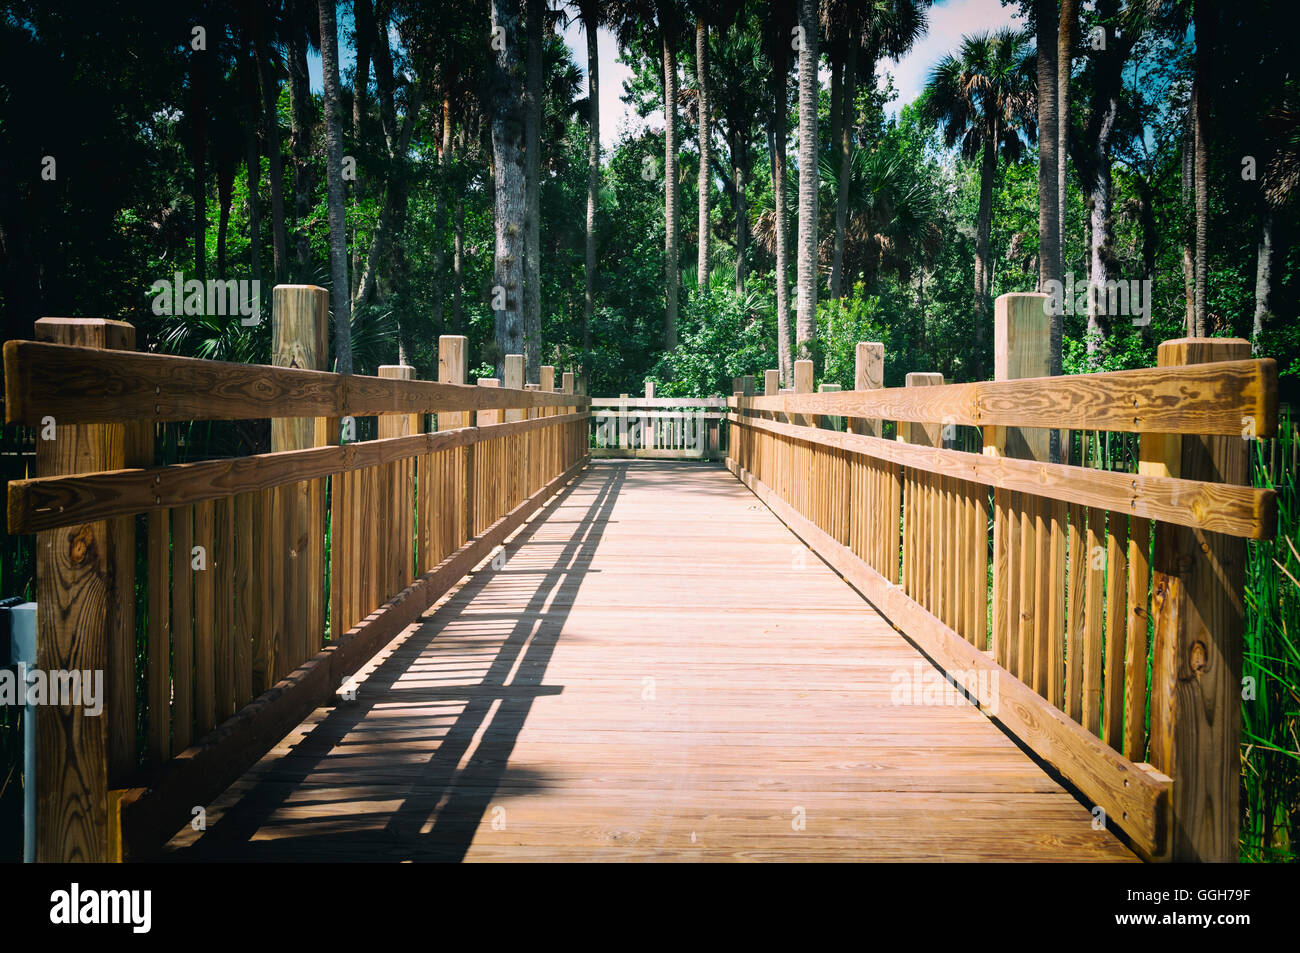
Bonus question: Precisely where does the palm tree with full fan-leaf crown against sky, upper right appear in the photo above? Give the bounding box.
[923,29,1035,377]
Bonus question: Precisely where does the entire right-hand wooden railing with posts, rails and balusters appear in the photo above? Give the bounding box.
[728,295,1277,861]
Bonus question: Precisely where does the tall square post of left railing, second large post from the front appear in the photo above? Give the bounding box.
[269,285,329,670]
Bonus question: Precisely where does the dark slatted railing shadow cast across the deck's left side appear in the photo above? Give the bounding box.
[169,464,628,861]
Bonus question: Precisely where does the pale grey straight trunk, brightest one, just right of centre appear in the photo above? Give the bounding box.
[794,0,818,359]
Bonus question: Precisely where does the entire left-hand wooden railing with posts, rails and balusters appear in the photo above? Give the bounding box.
[4,286,589,861]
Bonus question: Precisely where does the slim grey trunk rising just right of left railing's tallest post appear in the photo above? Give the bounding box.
[317,0,352,374]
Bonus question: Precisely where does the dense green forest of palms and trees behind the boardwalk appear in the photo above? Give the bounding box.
[0,0,1300,859]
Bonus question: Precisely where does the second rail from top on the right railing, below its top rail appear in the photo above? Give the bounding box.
[727,413,1277,540]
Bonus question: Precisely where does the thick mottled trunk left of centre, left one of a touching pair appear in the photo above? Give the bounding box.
[488,0,528,380]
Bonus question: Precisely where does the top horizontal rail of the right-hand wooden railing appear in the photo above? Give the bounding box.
[728,359,1278,437]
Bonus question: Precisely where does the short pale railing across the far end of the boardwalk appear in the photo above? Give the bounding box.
[590,385,727,460]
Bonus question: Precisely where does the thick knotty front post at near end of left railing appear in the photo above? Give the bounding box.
[33,317,139,863]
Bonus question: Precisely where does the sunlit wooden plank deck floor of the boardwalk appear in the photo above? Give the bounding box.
[169,462,1136,861]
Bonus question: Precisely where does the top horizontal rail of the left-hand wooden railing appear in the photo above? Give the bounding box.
[4,341,588,426]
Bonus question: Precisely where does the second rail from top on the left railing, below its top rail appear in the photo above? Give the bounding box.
[8,413,588,533]
